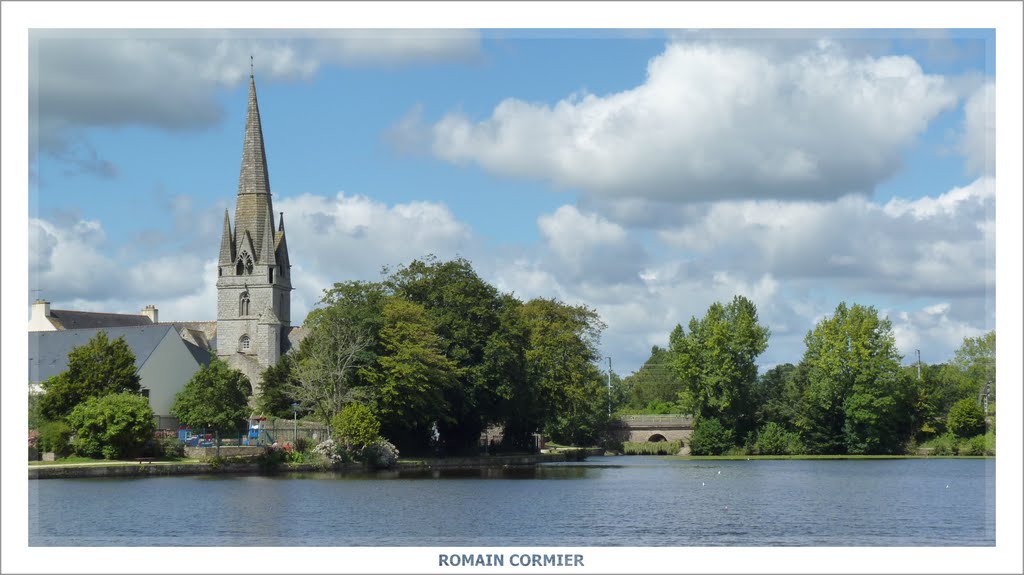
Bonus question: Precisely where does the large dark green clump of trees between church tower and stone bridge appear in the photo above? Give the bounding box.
[258,257,608,454]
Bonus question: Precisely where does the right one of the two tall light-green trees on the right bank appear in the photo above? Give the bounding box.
[798,303,913,453]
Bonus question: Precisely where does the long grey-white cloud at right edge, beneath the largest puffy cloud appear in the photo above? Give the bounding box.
[659,178,995,297]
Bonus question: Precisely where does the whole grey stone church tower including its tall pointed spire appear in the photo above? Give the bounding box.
[217,64,292,395]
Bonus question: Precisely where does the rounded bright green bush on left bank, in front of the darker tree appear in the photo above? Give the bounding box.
[68,393,157,459]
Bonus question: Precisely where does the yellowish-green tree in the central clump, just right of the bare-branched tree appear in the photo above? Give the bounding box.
[374,297,459,446]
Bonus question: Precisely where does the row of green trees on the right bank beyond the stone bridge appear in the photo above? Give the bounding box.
[622,296,995,454]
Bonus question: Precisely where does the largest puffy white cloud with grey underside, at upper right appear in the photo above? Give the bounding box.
[433,43,956,202]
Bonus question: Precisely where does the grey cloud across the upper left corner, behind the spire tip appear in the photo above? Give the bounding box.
[29,30,479,161]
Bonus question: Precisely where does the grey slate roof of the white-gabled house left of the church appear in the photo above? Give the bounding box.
[29,324,184,384]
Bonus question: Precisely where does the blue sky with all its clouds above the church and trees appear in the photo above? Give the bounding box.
[29,29,995,374]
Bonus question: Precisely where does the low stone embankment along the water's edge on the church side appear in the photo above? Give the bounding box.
[29,449,603,480]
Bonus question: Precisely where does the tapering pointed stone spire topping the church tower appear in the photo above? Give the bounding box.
[234,67,273,260]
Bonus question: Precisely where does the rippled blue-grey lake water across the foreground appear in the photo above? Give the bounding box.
[29,457,995,546]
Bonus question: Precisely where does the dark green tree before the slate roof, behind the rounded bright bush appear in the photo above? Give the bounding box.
[39,331,141,419]
